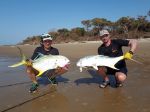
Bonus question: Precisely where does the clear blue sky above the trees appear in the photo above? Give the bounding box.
[0,0,150,45]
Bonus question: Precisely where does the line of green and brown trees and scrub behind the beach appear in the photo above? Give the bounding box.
[19,11,150,44]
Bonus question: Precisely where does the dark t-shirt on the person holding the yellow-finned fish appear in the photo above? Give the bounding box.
[31,46,59,60]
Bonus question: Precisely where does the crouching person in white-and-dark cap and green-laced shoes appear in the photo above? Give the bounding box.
[27,34,66,92]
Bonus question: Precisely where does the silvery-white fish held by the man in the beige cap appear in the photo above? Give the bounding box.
[76,55,125,72]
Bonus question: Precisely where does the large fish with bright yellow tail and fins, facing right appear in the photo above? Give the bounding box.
[9,48,70,76]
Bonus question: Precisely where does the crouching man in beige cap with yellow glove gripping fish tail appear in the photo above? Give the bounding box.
[98,30,137,88]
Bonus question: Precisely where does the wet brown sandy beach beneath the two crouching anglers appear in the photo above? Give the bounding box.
[0,39,150,112]
